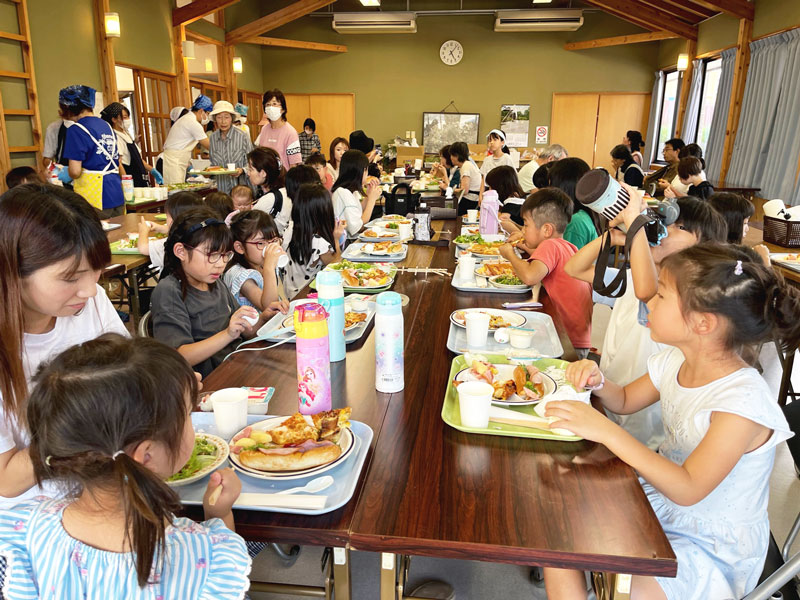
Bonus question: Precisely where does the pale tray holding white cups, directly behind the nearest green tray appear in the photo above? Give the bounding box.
[447,309,564,361]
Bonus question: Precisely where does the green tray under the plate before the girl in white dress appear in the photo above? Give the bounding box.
[442,354,583,442]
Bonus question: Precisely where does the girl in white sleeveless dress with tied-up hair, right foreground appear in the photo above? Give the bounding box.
[545,244,800,600]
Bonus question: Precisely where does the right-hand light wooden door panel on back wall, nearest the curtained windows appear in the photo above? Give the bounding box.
[587,93,650,172]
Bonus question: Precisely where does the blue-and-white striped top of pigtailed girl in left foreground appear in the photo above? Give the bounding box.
[0,500,251,600]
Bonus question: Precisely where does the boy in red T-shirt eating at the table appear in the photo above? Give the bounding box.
[500,188,592,358]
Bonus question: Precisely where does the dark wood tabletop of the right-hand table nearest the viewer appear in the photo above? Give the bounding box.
[350,224,677,576]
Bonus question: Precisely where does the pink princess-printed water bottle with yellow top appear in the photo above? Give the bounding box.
[294,302,331,415]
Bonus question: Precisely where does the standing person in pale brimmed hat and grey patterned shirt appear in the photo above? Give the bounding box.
[208,100,253,194]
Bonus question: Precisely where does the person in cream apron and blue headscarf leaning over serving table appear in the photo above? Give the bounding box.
[164,94,213,184]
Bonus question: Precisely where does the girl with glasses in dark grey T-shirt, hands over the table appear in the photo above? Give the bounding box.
[151,208,286,377]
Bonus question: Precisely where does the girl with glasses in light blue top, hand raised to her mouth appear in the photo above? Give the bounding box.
[223,210,284,310]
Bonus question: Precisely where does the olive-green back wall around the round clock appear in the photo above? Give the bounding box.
[263,12,658,149]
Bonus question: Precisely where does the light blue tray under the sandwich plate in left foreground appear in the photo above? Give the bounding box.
[175,412,373,515]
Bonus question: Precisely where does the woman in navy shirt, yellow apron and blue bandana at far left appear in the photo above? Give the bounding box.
[58,85,125,219]
